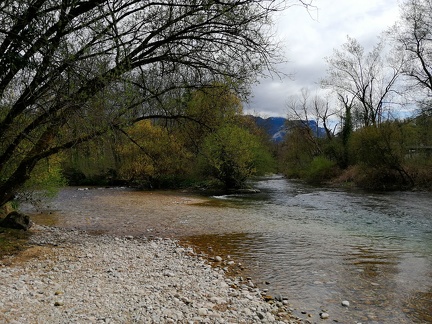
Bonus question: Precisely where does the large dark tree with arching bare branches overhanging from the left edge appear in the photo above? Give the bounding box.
[0,0,310,206]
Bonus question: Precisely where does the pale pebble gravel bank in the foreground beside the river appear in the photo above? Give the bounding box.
[0,226,300,323]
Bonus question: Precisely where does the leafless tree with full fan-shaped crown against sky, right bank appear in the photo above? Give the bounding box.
[322,37,403,126]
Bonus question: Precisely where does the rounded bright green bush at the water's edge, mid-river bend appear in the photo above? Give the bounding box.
[200,125,272,188]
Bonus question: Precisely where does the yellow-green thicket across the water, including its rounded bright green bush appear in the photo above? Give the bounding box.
[60,83,275,188]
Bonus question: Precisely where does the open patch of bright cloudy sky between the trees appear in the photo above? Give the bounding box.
[244,0,399,117]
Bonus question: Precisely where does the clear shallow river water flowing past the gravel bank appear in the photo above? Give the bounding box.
[27,176,432,323]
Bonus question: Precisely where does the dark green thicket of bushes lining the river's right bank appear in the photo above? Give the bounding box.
[279,115,432,190]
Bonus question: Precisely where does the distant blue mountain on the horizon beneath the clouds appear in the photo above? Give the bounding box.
[253,116,325,142]
